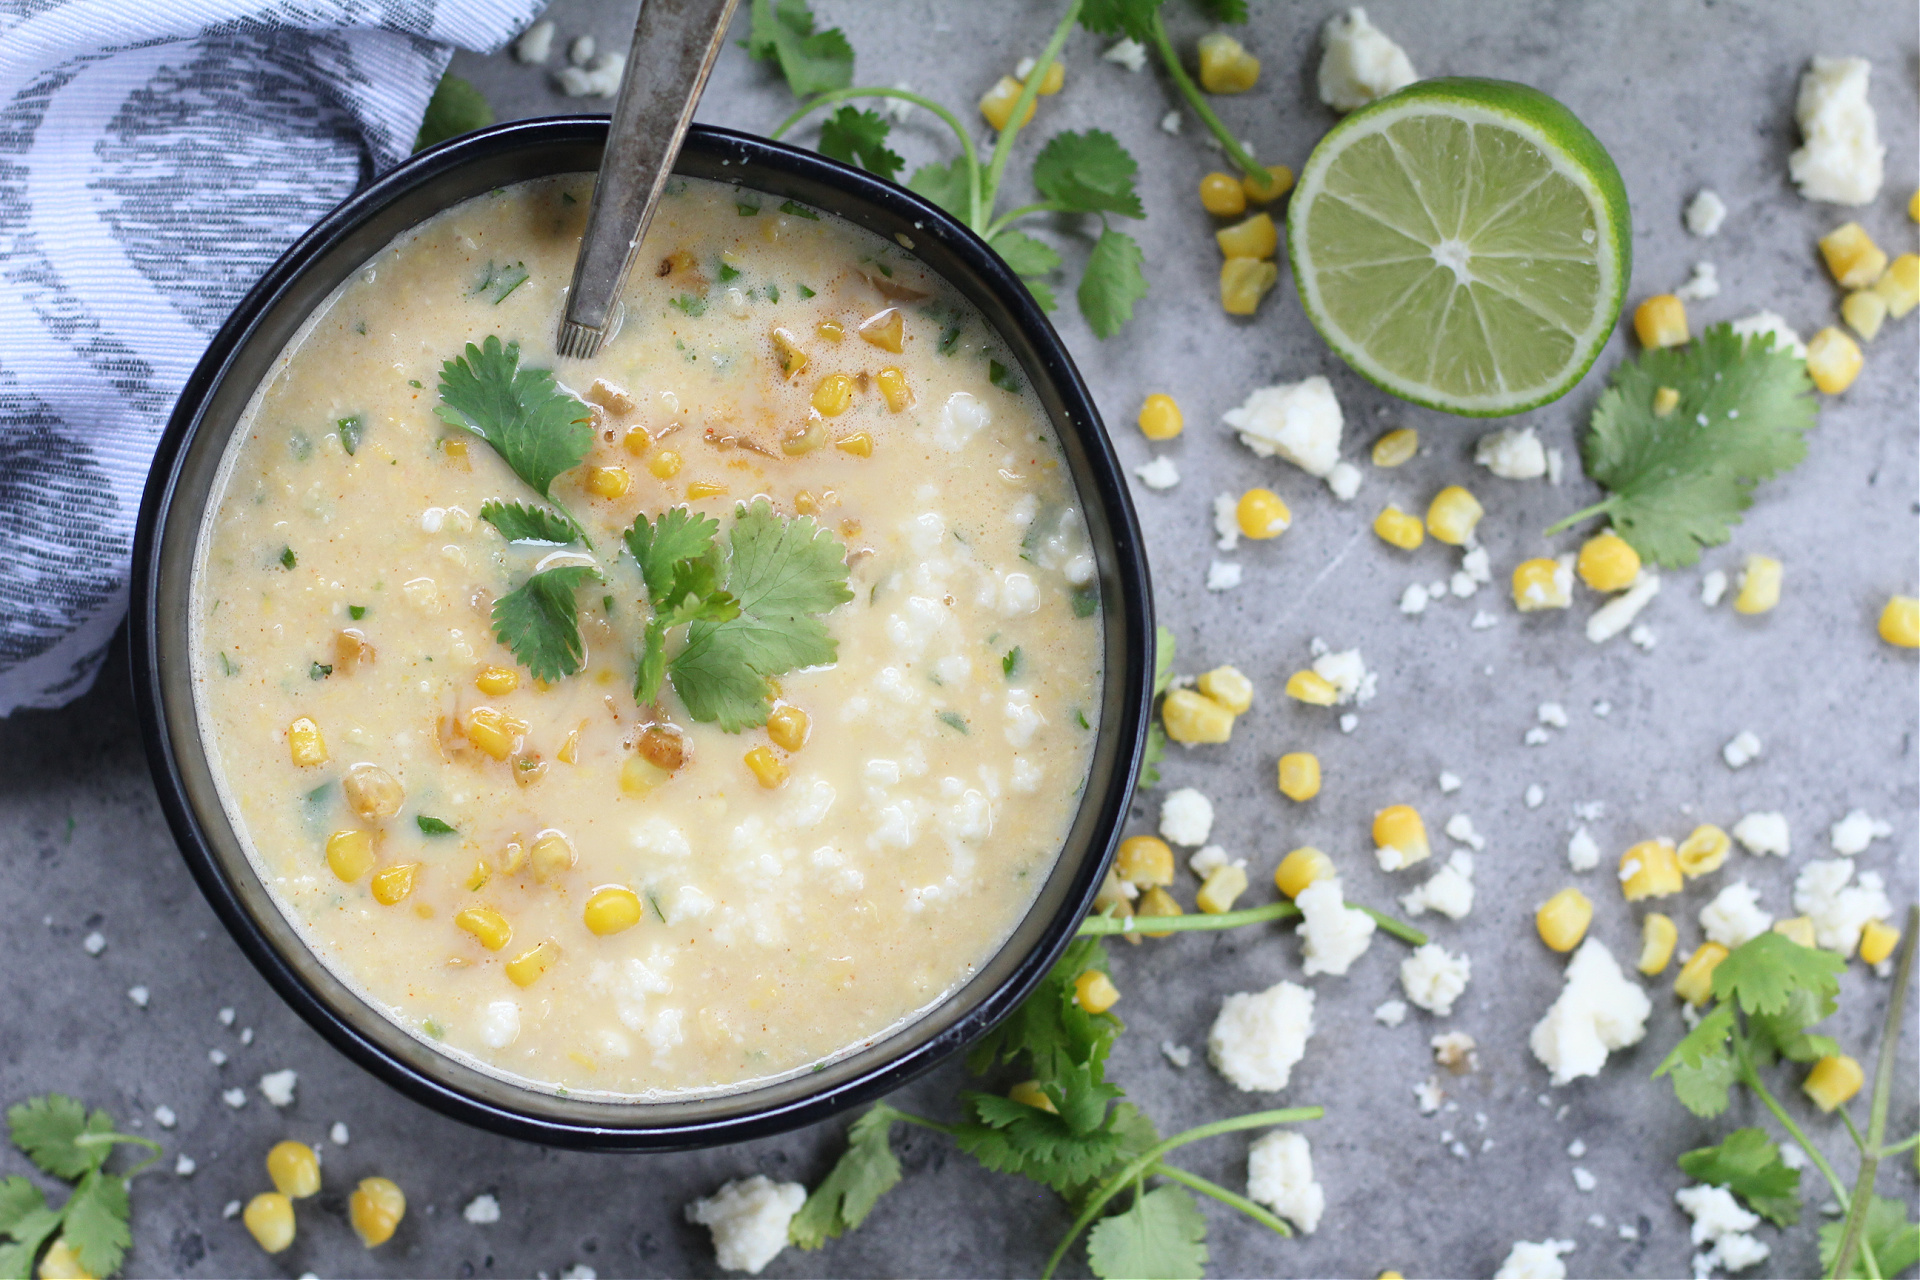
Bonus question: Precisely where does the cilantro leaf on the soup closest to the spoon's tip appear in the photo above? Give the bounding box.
[434,334,593,503]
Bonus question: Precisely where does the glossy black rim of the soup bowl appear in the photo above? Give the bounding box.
[129,115,1154,1151]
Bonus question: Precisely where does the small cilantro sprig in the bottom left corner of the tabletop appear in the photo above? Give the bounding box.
[0,1094,161,1280]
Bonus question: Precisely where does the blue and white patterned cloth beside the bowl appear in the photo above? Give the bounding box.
[0,0,545,716]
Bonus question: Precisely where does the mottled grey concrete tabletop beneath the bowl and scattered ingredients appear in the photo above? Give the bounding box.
[0,0,1920,1276]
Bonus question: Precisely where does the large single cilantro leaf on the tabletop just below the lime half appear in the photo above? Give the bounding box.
[1580,324,1818,566]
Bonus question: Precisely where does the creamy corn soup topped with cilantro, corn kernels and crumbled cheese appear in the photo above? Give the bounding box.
[194,175,1102,1100]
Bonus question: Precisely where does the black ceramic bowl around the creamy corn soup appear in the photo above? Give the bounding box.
[132,117,1154,1150]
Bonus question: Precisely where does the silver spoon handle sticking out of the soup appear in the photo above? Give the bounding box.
[559,0,739,361]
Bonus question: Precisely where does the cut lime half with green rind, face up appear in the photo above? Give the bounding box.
[1286,79,1632,416]
